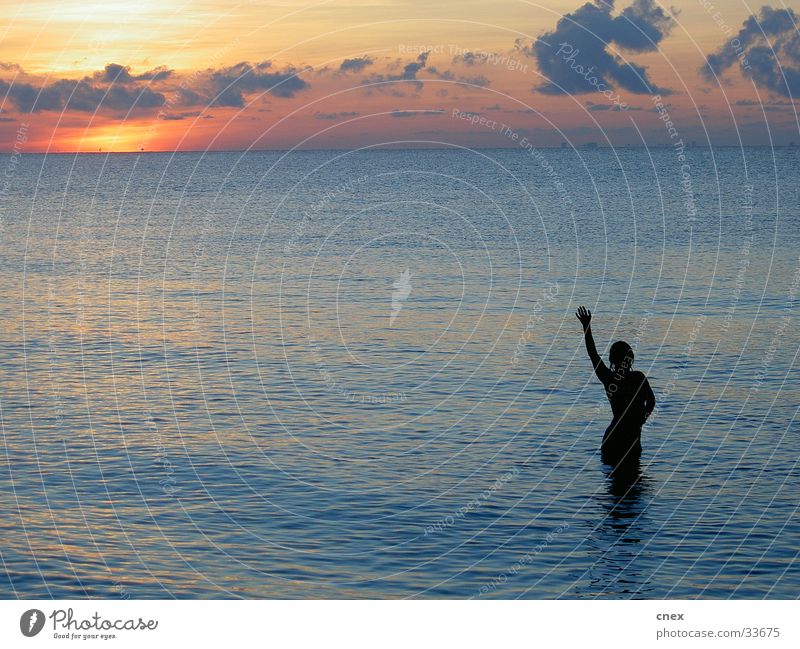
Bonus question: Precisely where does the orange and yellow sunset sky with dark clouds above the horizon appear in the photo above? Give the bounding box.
[0,0,800,152]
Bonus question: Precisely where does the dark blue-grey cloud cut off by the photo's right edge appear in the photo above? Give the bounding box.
[702,6,800,98]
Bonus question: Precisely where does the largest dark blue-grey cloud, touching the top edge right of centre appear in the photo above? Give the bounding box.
[517,0,675,94]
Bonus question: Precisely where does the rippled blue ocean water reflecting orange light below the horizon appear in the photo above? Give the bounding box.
[0,148,800,598]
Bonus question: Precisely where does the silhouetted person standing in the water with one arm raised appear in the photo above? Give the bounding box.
[575,306,656,468]
